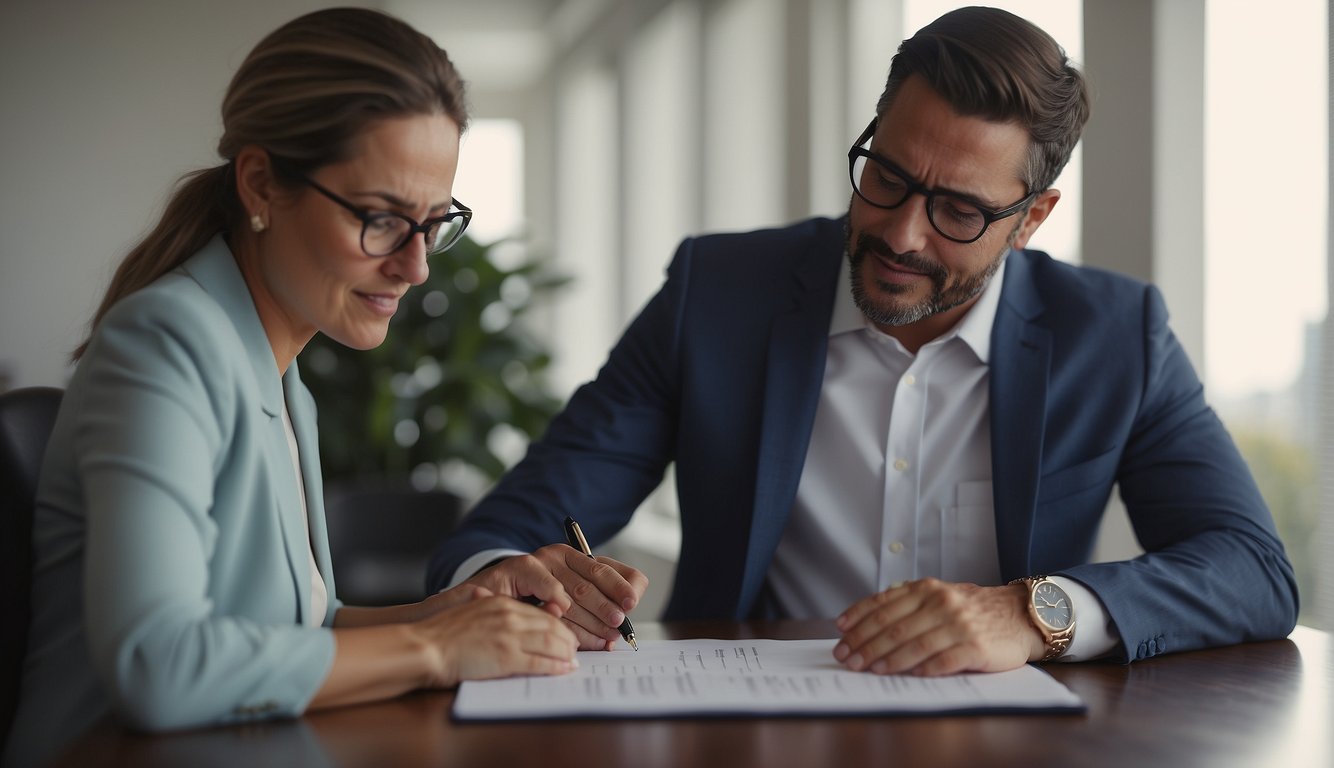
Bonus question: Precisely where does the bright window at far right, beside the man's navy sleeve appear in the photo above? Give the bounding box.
[1205,0,1331,627]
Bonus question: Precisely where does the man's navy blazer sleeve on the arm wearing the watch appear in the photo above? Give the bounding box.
[1062,287,1298,661]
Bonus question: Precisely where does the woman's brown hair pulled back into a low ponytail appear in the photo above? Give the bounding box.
[73,8,468,360]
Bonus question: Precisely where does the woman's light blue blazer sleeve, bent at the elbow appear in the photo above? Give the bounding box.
[73,293,334,729]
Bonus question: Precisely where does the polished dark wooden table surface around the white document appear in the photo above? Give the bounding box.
[49,621,1334,768]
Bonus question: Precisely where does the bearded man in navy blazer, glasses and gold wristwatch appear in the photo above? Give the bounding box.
[442,8,1297,675]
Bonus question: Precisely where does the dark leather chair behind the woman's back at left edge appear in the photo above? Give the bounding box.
[0,387,64,749]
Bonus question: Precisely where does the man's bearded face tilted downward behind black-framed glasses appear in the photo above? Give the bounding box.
[847,75,1059,349]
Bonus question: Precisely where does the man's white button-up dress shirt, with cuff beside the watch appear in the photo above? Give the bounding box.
[768,260,1115,660]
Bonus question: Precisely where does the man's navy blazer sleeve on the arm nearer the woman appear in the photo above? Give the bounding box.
[427,240,692,591]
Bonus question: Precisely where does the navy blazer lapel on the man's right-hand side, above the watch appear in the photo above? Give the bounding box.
[990,251,1051,580]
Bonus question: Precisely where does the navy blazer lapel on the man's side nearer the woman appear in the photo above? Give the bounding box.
[736,229,843,616]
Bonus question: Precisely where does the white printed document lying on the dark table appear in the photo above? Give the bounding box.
[454,640,1085,720]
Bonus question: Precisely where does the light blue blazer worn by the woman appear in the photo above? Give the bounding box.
[5,236,340,765]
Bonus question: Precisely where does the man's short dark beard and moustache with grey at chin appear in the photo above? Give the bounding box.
[844,223,1018,325]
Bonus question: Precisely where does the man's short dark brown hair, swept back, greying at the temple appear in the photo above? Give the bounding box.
[875,7,1089,192]
